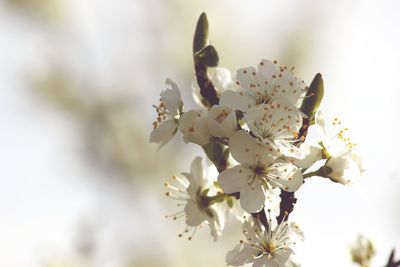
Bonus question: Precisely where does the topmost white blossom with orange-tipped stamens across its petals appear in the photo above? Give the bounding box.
[220,59,306,112]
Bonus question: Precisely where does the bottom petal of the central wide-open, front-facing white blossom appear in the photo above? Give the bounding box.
[240,184,265,213]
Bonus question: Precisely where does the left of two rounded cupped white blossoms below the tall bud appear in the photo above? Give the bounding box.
[179,109,211,145]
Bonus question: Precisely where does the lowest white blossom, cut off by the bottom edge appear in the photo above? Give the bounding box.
[226,217,304,267]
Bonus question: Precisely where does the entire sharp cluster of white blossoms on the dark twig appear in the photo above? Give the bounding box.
[150,12,363,266]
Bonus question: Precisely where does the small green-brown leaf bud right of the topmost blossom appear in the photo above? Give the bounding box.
[300,73,324,125]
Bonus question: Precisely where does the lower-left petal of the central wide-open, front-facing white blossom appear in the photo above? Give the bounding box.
[218,165,250,194]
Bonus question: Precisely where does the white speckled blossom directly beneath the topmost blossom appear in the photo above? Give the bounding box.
[245,101,304,158]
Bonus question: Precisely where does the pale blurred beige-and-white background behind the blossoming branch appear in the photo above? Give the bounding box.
[0,0,400,267]
